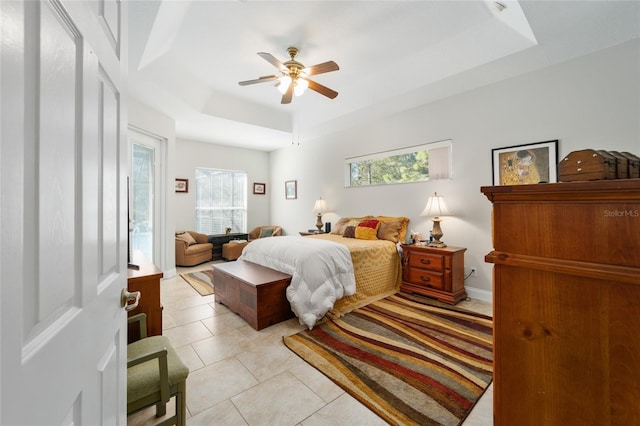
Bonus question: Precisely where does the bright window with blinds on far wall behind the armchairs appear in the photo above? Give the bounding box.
[196,168,247,235]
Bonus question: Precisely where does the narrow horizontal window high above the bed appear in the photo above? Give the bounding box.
[345,140,451,187]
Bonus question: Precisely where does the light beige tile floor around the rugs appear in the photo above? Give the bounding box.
[128,262,493,426]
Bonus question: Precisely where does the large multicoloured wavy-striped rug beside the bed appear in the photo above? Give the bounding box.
[284,293,493,425]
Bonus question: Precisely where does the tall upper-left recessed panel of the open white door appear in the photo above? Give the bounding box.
[30,0,82,342]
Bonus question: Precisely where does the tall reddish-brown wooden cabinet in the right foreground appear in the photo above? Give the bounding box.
[481,179,640,426]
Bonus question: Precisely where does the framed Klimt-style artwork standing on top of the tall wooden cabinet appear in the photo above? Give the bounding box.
[491,140,558,185]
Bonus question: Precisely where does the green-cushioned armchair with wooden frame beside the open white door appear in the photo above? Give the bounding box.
[127,313,189,426]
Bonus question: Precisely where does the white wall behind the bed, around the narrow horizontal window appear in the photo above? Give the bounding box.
[270,40,640,300]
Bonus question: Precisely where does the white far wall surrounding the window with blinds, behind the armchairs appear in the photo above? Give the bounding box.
[174,139,273,231]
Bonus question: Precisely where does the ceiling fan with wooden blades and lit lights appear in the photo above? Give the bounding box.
[238,47,340,104]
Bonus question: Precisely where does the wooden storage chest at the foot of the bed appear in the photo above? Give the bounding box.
[213,260,294,330]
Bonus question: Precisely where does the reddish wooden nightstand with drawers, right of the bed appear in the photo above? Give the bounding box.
[400,244,467,304]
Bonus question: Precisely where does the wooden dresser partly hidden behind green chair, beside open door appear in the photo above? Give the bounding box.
[127,259,163,343]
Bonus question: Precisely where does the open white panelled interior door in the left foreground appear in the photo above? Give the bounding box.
[0,0,127,425]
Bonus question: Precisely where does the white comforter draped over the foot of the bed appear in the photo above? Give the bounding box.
[239,236,356,330]
